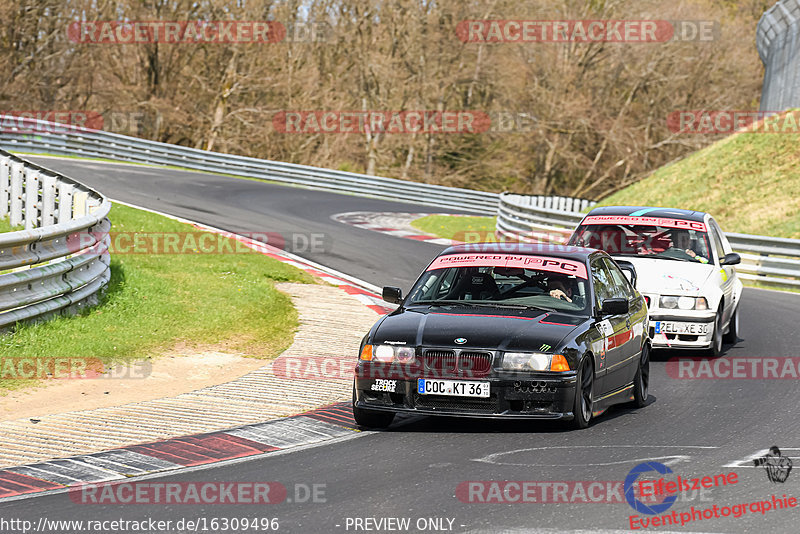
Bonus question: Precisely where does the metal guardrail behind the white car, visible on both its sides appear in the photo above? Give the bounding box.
[497,193,800,289]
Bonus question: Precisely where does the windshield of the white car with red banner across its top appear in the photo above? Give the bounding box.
[569,223,711,263]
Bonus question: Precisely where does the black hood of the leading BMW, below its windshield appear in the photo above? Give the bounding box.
[372,307,588,351]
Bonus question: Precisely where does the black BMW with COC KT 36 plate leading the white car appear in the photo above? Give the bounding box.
[353,243,650,428]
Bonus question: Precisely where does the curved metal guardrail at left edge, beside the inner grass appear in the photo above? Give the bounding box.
[0,150,111,330]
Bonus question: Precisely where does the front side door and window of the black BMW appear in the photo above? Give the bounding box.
[591,258,627,393]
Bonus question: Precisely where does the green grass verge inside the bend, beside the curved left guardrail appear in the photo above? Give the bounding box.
[0,205,313,389]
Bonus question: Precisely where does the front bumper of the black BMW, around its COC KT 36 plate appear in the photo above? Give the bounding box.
[355,370,576,420]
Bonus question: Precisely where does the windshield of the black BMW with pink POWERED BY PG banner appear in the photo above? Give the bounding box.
[405,254,590,314]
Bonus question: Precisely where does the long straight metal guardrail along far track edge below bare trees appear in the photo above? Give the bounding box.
[0,115,498,215]
